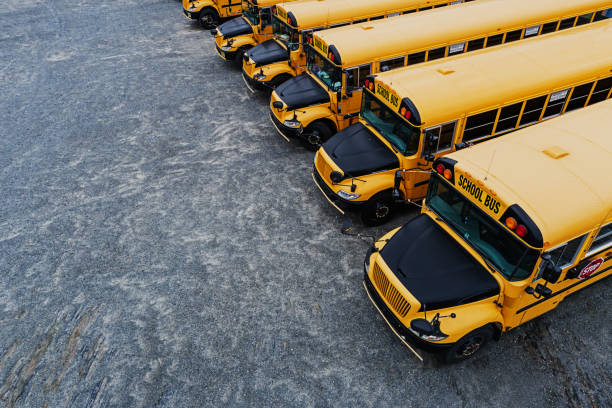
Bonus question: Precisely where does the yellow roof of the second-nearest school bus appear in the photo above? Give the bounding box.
[376,20,612,127]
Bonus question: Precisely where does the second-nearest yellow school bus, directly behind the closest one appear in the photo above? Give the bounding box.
[313,19,612,224]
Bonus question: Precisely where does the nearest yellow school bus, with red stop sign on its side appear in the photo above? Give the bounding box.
[363,101,612,362]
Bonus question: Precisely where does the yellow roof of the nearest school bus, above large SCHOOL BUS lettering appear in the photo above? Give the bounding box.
[446,100,612,248]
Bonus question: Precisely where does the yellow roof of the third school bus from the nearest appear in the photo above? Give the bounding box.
[316,0,612,67]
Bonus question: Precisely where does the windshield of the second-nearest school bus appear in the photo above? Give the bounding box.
[361,89,421,156]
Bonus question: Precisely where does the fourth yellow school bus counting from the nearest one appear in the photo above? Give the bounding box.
[243,0,462,92]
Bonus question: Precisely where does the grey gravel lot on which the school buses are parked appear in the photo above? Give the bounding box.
[0,0,612,407]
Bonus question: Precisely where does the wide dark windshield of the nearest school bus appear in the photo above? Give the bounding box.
[427,174,539,281]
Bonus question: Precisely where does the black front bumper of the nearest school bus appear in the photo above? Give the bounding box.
[363,272,453,361]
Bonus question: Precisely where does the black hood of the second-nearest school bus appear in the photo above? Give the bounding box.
[323,122,399,178]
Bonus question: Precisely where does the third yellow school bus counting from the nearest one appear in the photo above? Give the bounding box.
[270,0,612,148]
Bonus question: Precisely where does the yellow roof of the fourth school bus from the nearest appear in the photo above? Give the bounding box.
[277,0,447,30]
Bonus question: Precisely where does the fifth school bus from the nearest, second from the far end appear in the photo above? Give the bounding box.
[211,0,292,68]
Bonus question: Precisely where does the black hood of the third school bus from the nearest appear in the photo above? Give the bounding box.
[276,73,329,110]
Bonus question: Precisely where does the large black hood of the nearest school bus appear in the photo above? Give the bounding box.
[380,214,500,310]
